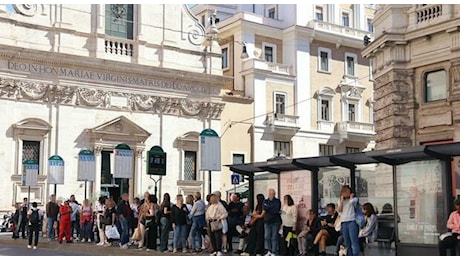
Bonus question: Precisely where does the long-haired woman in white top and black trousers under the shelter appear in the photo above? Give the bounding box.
[280,195,297,256]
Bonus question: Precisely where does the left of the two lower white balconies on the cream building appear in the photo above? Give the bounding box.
[264,113,300,136]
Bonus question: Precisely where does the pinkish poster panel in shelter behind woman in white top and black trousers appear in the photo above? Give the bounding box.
[279,170,311,230]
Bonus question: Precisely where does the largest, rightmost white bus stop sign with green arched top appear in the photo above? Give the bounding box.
[200,128,221,171]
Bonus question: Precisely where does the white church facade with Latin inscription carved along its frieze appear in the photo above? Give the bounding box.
[0,4,231,210]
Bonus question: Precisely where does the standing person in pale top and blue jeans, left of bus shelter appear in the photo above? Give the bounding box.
[189,192,206,253]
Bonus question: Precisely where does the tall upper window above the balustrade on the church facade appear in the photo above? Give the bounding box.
[105,4,134,40]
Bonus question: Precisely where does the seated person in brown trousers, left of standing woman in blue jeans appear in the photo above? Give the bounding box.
[313,203,339,255]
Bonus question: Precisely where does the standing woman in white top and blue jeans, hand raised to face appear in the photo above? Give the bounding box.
[338,185,360,256]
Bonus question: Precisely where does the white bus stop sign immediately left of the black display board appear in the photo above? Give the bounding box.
[113,144,134,179]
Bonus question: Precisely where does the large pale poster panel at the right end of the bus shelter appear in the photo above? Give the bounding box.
[396,161,447,244]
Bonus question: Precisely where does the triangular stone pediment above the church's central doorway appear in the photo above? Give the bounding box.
[86,116,151,143]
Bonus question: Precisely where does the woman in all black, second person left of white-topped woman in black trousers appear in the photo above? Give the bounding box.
[241,194,265,256]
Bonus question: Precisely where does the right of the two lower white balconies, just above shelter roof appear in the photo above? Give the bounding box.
[337,121,375,141]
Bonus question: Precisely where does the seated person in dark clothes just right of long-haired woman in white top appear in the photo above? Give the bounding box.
[297,209,321,256]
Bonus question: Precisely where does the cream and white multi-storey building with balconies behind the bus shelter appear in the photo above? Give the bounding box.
[191,4,375,199]
